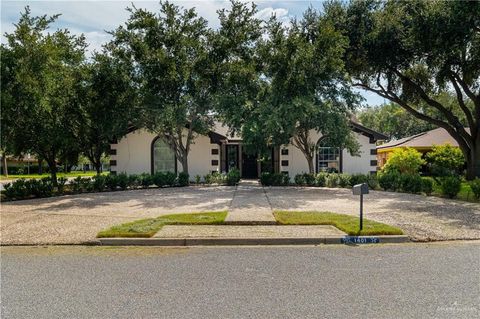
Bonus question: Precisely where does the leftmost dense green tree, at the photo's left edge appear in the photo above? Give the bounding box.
[2,7,86,184]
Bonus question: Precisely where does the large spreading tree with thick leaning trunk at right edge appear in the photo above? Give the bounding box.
[326,0,480,180]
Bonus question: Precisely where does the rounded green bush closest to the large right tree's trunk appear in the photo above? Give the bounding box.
[425,144,465,176]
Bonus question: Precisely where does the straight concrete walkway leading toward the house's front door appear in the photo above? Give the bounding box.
[225,180,275,225]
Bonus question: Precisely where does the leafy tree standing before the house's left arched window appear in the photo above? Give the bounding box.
[109,2,213,173]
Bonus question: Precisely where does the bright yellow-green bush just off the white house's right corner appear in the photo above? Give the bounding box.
[382,147,425,175]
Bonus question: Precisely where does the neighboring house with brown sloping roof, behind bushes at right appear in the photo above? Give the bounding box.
[377,128,470,168]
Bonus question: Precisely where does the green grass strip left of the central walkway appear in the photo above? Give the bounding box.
[97,211,227,238]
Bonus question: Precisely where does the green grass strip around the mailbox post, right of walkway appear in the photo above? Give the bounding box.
[273,211,403,236]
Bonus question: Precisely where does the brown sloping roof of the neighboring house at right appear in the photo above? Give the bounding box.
[377,127,469,149]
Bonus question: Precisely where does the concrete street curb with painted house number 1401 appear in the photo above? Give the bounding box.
[99,235,410,246]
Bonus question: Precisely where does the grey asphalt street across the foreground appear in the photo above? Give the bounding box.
[1,241,480,319]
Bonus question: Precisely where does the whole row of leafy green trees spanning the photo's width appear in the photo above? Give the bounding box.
[1,1,480,184]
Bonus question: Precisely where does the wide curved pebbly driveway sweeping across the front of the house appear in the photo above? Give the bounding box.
[0,186,480,245]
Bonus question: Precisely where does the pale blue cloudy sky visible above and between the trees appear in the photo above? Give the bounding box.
[1,0,384,105]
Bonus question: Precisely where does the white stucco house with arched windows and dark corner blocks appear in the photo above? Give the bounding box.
[110,121,387,179]
